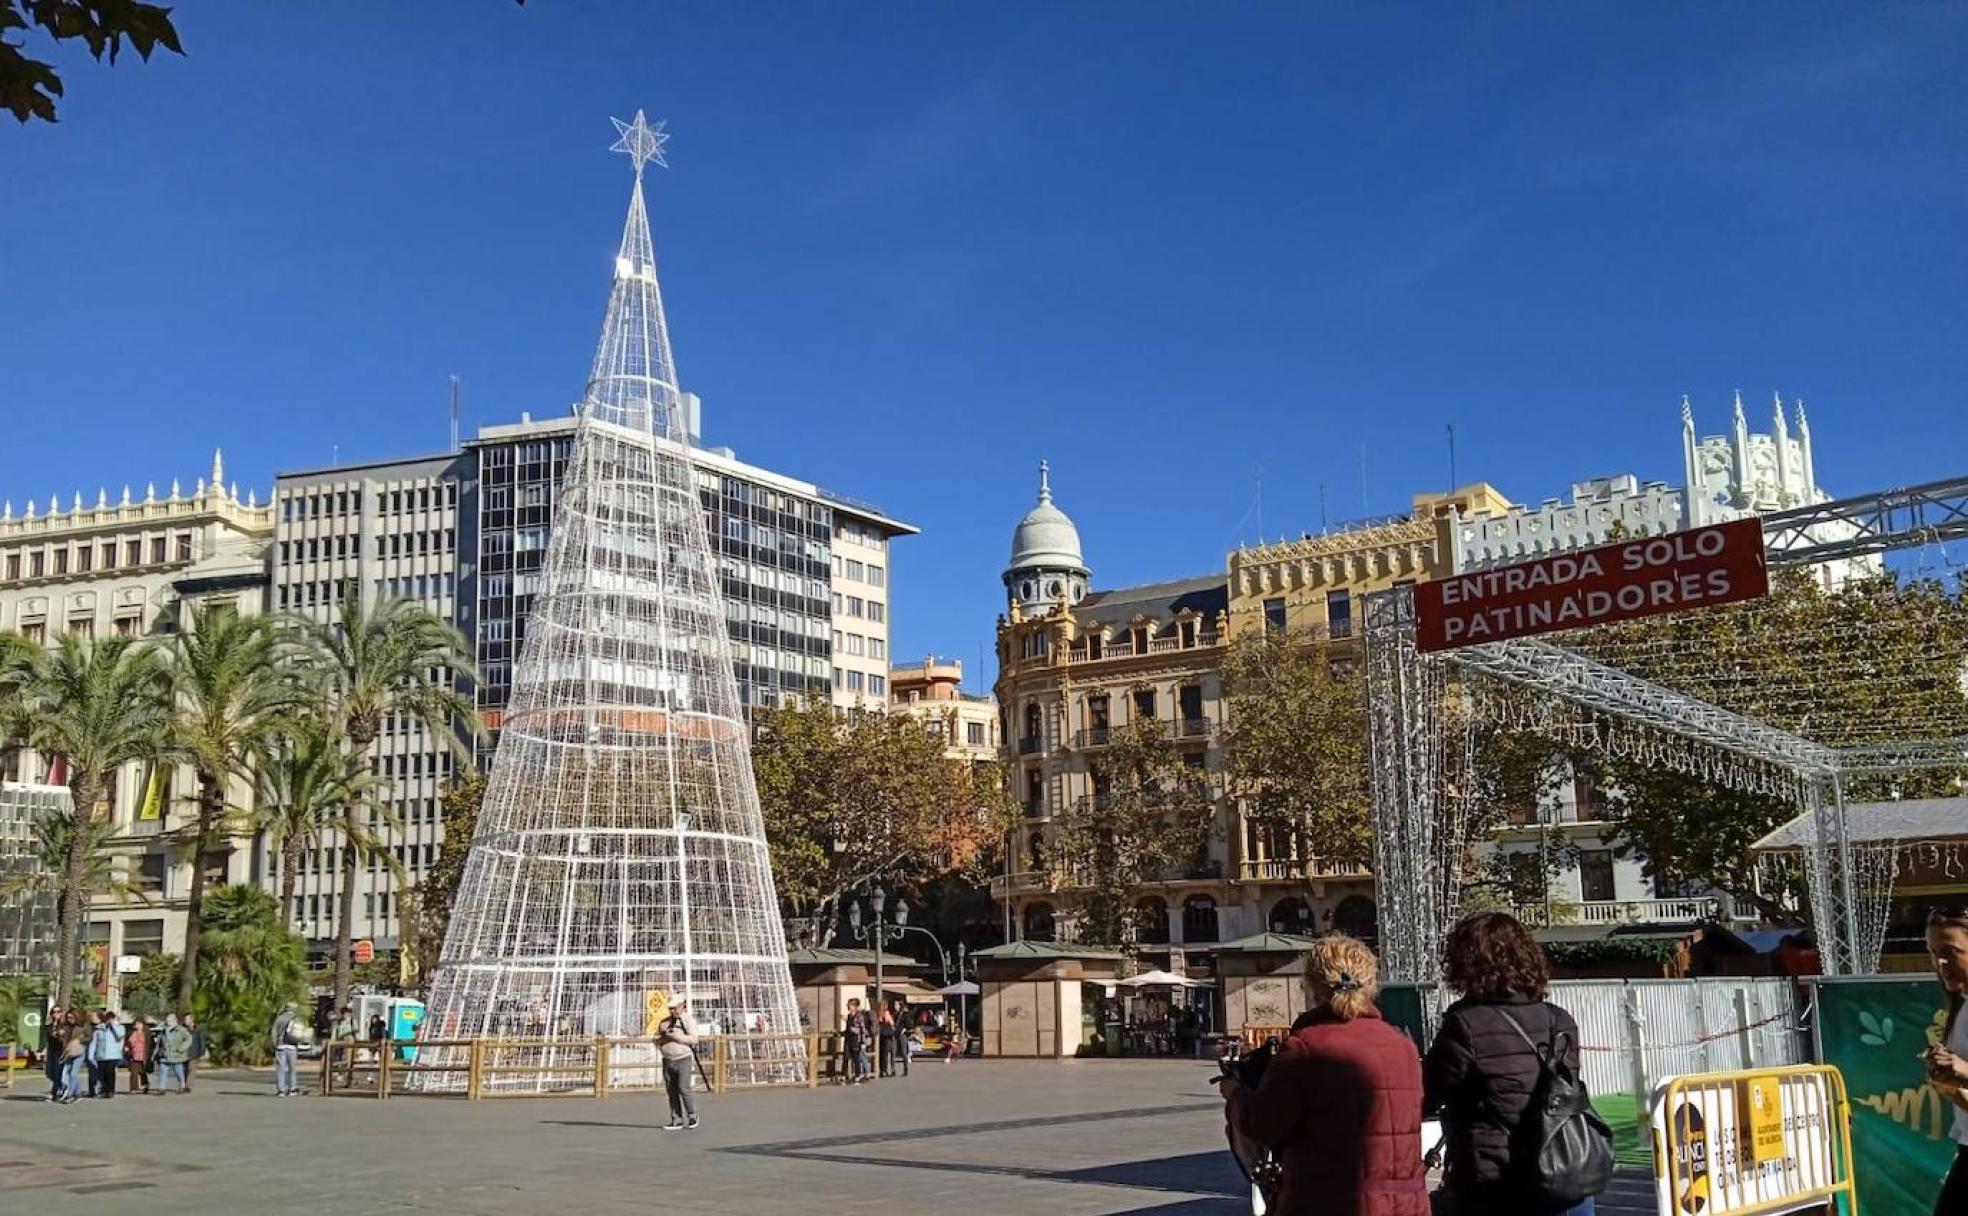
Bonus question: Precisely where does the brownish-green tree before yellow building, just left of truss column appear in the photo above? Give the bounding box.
[1222,632,1374,864]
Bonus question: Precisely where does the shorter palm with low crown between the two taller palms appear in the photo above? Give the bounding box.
[252,720,382,925]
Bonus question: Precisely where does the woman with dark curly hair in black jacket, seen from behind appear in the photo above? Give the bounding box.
[1421,913,1594,1216]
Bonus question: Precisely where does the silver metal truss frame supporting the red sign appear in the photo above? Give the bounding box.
[1364,478,1968,984]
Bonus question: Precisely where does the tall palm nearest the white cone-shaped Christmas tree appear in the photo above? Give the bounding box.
[293,594,478,1005]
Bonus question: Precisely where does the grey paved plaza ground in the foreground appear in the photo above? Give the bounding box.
[0,1061,1653,1216]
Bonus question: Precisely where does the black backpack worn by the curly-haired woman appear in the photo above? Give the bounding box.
[1498,1009,1614,1208]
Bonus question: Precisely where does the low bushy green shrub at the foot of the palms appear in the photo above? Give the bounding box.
[193,883,307,1064]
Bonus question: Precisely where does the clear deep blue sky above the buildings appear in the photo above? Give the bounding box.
[0,0,1968,676]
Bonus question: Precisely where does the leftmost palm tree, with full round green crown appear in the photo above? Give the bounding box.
[0,634,171,1005]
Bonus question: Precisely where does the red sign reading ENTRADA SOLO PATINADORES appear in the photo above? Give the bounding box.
[1415,517,1769,651]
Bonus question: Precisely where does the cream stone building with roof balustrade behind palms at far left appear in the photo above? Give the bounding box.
[0,453,274,1000]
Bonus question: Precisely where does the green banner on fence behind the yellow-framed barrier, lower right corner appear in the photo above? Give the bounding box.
[1816,976,1954,1216]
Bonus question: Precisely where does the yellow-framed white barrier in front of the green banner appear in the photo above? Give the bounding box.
[1649,1064,1858,1216]
